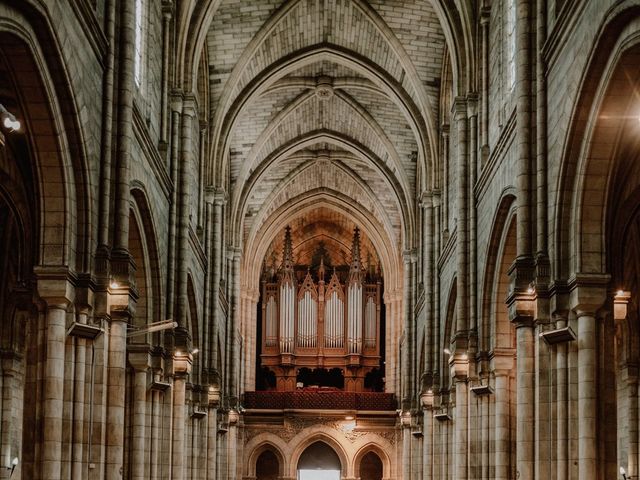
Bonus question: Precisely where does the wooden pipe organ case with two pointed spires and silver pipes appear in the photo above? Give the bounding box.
[260,227,383,392]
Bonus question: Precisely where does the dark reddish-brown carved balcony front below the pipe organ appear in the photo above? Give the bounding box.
[244,388,398,411]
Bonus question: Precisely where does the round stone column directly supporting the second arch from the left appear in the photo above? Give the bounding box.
[129,351,151,480]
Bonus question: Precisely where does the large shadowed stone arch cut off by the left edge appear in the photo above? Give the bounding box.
[0,4,92,271]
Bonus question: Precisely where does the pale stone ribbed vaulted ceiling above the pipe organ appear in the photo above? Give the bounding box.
[207,0,445,288]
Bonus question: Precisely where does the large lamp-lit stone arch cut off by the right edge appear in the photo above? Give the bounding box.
[553,1,640,278]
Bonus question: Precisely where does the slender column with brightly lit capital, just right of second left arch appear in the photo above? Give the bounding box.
[171,352,193,480]
